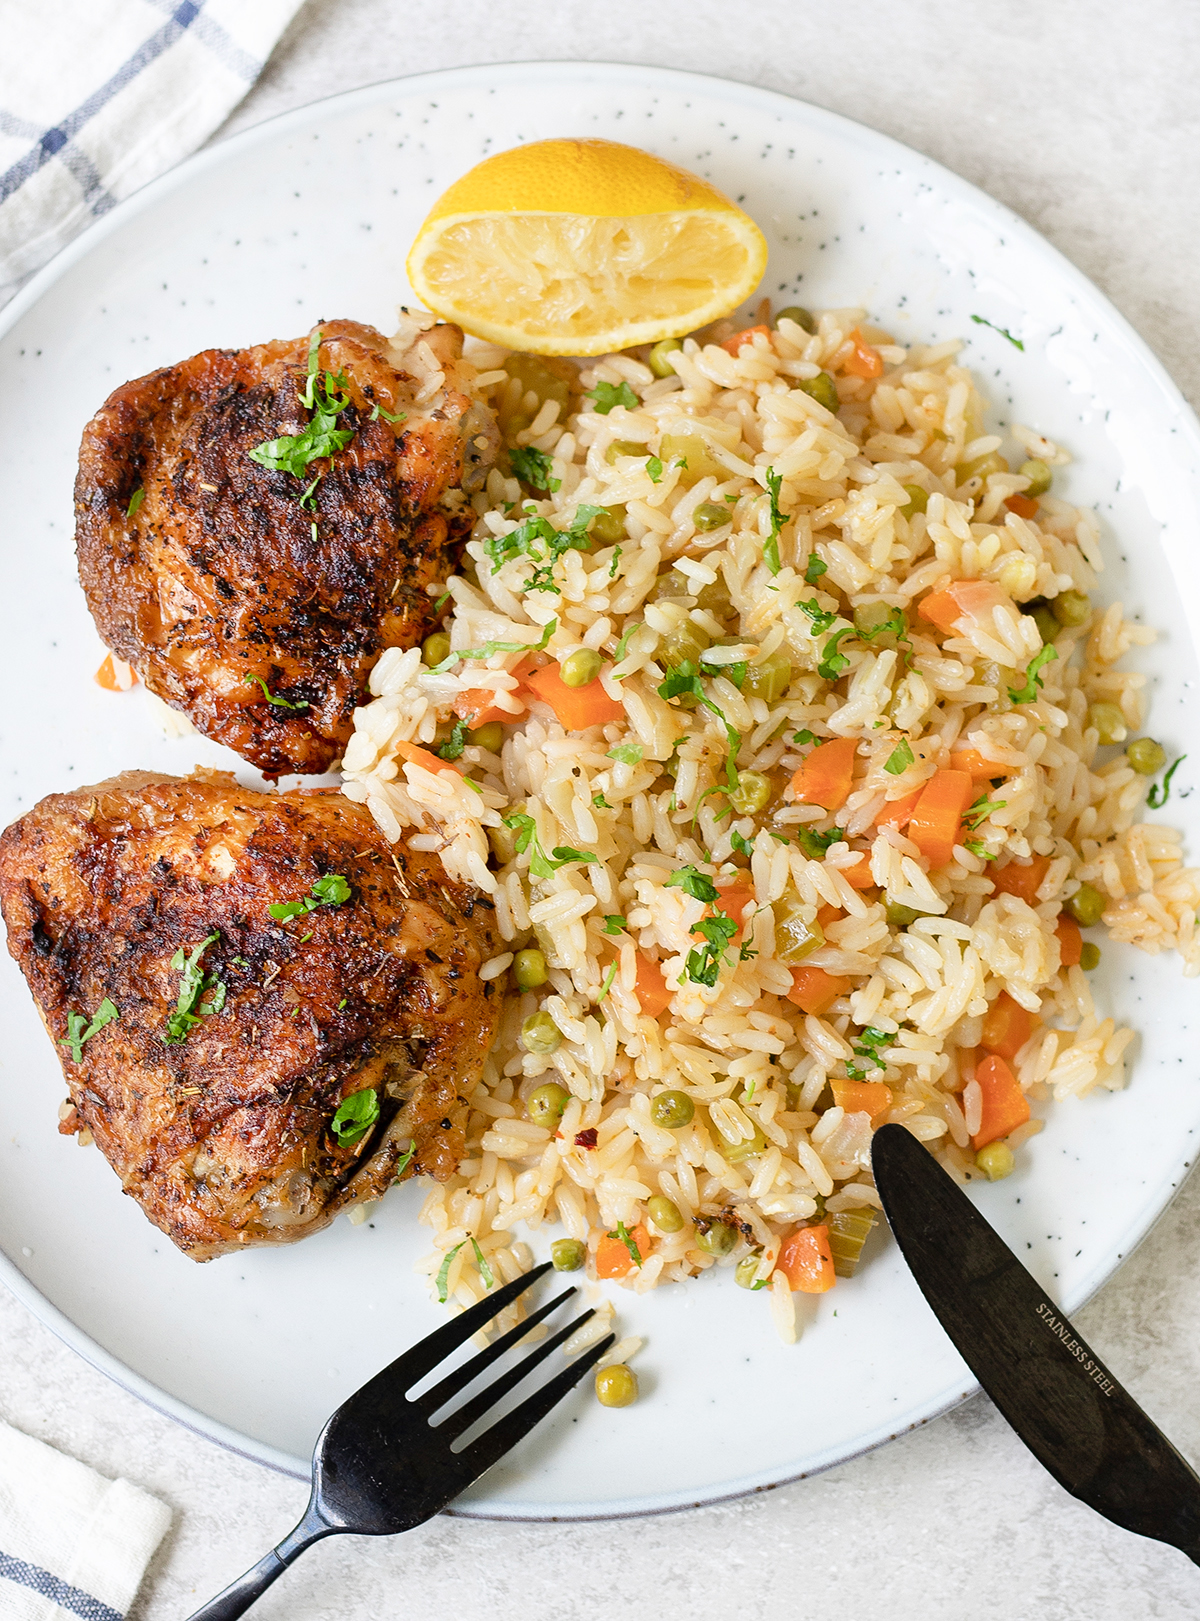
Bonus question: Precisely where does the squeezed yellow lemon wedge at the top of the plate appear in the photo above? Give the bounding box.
[409,139,767,355]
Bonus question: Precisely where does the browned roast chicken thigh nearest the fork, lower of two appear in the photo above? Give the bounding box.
[0,772,499,1261]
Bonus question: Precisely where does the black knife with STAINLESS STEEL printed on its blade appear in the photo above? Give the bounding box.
[871,1125,1200,1564]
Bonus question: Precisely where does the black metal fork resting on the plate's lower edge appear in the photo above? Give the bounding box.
[191,1261,615,1621]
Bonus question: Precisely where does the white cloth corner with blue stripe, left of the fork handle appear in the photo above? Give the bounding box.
[0,1423,170,1621]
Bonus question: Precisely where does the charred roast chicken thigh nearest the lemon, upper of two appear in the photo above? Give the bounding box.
[75,321,498,778]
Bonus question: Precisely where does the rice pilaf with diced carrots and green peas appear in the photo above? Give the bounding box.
[344,310,1200,1339]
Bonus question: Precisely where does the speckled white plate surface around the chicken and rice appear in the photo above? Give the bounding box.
[0,63,1200,1519]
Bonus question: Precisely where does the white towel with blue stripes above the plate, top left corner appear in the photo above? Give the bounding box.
[0,0,302,303]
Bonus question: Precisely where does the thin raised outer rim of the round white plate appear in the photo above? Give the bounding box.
[0,58,1200,1524]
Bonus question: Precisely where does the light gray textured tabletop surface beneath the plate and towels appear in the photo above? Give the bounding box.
[0,0,1200,1621]
